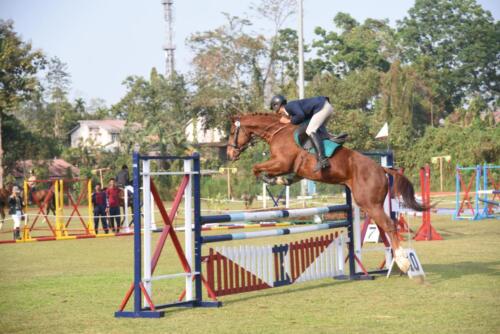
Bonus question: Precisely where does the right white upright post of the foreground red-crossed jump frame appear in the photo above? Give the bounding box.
[184,160,194,301]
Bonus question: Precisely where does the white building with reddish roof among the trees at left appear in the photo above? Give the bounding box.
[69,119,126,151]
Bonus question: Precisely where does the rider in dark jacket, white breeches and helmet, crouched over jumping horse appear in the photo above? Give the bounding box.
[271,95,340,171]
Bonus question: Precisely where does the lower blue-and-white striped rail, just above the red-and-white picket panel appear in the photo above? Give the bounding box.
[201,220,350,244]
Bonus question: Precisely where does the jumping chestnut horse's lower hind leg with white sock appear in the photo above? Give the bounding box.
[365,206,410,273]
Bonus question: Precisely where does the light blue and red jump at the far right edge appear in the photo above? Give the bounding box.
[453,164,500,220]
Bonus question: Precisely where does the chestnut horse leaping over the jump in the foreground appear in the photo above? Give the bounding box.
[227,113,428,273]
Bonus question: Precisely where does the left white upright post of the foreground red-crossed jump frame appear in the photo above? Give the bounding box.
[142,160,153,306]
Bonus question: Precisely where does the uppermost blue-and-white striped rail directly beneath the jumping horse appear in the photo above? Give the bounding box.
[200,204,350,224]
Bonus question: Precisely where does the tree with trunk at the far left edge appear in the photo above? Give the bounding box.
[0,20,45,187]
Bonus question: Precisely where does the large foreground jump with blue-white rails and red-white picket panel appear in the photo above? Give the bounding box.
[115,152,373,318]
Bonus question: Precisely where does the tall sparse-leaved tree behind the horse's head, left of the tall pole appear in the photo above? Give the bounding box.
[188,14,265,128]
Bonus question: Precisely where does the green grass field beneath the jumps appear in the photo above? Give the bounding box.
[0,216,500,333]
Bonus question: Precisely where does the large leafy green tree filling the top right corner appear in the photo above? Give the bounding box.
[398,0,500,108]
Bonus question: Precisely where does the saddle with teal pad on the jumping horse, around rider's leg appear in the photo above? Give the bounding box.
[294,122,348,158]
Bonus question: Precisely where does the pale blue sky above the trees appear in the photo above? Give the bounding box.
[0,0,500,106]
